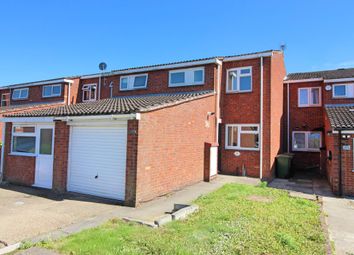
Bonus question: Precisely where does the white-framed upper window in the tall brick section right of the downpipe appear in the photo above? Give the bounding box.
[226,67,252,93]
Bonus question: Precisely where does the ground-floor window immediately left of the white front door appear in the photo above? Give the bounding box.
[11,126,36,155]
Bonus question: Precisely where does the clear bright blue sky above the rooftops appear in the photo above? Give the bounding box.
[0,0,354,85]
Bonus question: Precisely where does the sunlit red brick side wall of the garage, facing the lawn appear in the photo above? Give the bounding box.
[133,96,215,203]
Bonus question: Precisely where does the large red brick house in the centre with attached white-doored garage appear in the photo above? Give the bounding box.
[1,50,286,206]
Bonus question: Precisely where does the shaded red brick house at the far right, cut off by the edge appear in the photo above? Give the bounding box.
[283,68,354,195]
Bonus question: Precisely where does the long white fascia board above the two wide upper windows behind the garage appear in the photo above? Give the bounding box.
[81,58,220,80]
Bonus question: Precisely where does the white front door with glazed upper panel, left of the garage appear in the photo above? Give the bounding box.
[33,125,54,189]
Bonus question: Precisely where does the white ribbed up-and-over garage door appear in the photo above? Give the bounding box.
[67,122,127,201]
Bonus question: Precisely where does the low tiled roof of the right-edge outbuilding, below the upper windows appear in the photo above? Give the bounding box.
[325,104,354,130]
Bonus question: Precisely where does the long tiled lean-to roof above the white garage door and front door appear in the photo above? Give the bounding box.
[5,90,214,117]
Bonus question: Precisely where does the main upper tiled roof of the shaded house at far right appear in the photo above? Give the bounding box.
[285,68,354,81]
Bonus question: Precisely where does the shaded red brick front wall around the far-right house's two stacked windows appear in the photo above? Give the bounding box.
[283,81,324,169]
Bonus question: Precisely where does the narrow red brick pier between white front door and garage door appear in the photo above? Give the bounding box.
[53,121,70,192]
